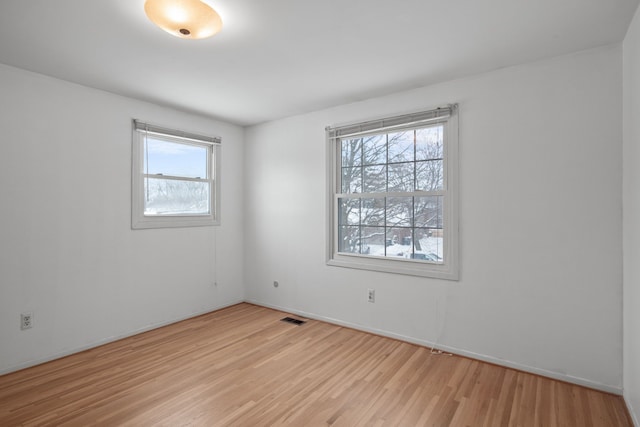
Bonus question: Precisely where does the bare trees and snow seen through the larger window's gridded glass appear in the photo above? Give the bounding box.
[337,124,444,264]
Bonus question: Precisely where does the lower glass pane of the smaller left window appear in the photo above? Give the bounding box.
[144,178,210,215]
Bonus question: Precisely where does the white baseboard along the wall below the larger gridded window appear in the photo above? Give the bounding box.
[246,299,624,394]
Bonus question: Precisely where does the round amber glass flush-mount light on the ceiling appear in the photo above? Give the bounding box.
[144,0,222,39]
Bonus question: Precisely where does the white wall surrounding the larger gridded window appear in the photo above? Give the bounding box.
[245,46,622,392]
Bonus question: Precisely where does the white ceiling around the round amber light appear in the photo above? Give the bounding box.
[0,0,639,125]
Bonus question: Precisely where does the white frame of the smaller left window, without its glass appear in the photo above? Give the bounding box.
[131,120,221,229]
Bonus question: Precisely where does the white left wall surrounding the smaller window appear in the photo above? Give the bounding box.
[0,65,244,373]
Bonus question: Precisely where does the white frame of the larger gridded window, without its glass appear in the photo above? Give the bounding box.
[326,104,459,280]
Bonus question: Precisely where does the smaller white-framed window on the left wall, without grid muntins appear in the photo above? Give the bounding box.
[132,120,220,228]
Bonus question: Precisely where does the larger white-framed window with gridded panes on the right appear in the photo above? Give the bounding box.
[327,105,458,280]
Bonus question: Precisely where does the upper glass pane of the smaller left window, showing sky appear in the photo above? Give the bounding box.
[143,137,209,179]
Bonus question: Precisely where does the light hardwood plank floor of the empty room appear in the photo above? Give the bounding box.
[0,304,632,427]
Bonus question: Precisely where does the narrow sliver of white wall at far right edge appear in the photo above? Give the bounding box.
[623,3,640,425]
